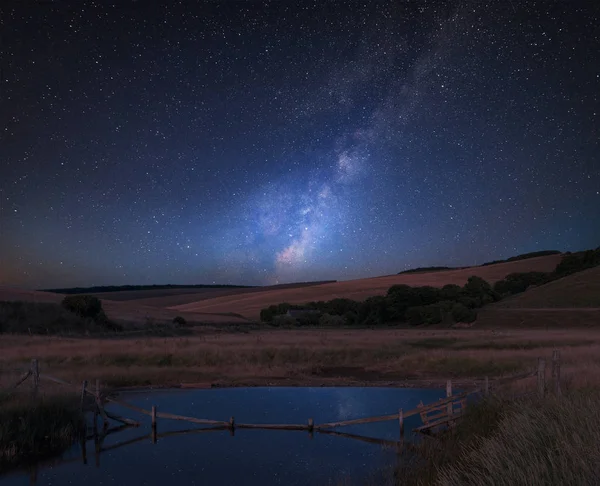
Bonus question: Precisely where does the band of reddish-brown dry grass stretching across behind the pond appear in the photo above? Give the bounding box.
[0,329,600,387]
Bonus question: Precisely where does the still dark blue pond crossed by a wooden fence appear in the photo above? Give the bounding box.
[0,387,445,486]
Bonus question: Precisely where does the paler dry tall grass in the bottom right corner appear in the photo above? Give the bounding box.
[434,391,600,486]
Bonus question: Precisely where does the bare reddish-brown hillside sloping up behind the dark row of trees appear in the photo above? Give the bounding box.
[171,255,562,319]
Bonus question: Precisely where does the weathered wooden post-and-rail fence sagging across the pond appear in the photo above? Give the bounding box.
[1,350,561,442]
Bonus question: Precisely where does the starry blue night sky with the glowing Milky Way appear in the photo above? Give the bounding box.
[0,0,600,288]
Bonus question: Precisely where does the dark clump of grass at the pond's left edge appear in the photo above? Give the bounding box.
[0,396,83,471]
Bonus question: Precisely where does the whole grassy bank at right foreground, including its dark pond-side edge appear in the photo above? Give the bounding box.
[396,389,600,486]
